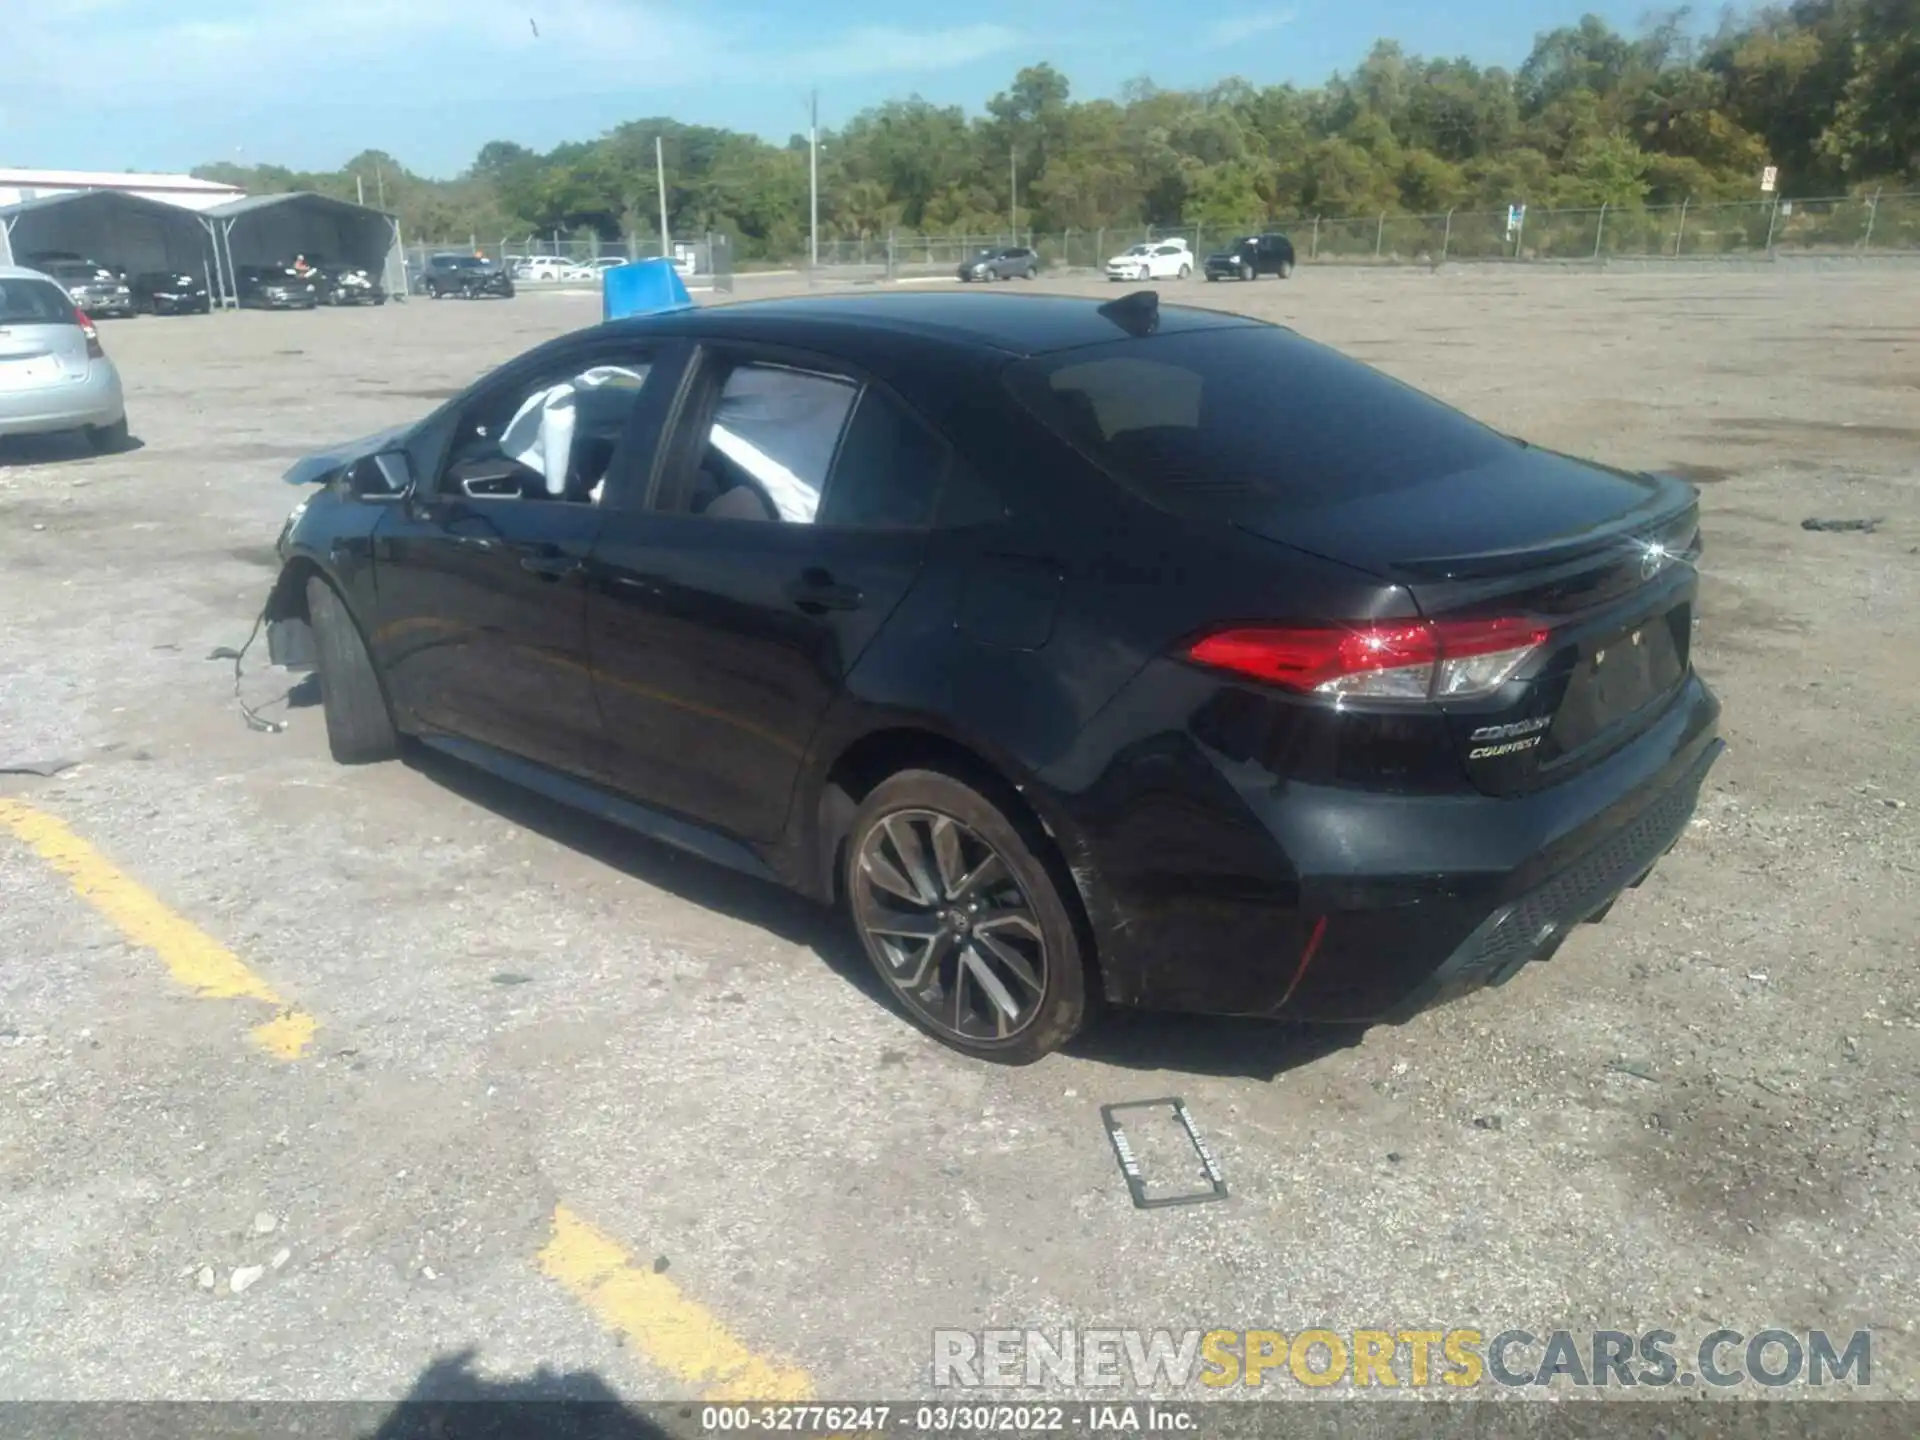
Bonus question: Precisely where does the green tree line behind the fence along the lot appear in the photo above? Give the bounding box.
[196,0,1920,259]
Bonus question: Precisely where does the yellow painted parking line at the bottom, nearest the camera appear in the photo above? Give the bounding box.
[538,1206,814,1400]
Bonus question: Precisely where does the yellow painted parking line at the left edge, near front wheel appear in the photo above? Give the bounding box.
[0,799,319,1060]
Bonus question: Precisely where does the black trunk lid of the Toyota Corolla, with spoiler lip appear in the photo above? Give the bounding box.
[1238,445,1699,795]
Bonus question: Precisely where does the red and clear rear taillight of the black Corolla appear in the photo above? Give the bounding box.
[1187,618,1548,701]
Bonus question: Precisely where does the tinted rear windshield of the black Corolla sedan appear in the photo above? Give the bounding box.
[1008,324,1517,518]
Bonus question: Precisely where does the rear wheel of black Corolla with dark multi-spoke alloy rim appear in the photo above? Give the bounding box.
[843,770,1089,1066]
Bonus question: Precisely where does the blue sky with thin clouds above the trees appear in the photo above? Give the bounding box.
[0,0,1645,175]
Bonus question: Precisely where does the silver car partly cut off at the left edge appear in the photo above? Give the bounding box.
[0,265,127,453]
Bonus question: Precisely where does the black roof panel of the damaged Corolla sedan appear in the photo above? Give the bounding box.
[611,292,1265,357]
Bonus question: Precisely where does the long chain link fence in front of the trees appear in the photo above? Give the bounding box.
[820,192,1920,278]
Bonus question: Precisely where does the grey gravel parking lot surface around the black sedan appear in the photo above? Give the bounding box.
[0,267,1920,1400]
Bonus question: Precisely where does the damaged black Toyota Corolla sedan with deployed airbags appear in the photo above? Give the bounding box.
[267,292,1720,1060]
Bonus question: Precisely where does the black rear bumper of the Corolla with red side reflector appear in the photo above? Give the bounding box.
[1050,676,1724,1021]
